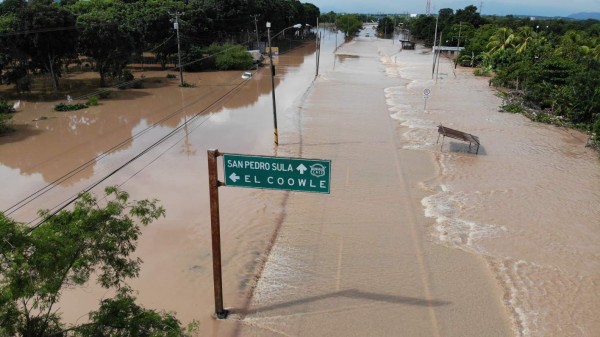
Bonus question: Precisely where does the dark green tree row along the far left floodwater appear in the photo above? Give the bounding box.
[0,0,320,92]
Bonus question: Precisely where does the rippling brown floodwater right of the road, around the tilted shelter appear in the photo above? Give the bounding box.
[384,46,600,336]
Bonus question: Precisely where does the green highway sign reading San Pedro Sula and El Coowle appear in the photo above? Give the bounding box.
[223,153,331,194]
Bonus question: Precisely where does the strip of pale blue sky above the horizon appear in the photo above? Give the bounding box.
[310,0,600,16]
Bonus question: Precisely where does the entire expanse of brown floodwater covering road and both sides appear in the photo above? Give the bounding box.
[0,24,600,337]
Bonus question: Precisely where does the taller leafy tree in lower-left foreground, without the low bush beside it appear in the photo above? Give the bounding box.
[0,187,173,337]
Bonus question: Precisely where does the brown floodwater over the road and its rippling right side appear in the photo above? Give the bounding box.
[234,28,600,337]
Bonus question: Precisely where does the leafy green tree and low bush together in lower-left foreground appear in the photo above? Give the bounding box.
[0,187,202,337]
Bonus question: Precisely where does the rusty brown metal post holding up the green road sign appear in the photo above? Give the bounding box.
[208,150,229,319]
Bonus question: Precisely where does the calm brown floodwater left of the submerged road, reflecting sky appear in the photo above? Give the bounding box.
[0,30,341,335]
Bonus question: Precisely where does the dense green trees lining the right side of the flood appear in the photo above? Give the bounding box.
[408,6,600,146]
